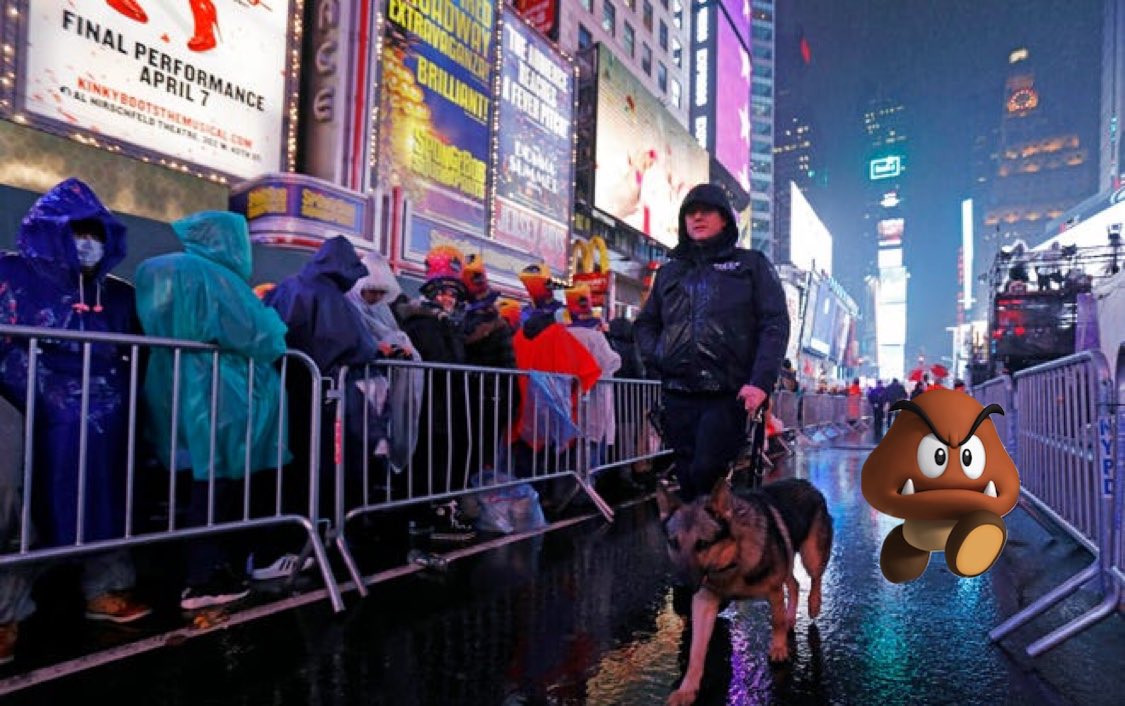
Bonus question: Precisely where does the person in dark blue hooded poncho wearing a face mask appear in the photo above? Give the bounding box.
[0,179,151,662]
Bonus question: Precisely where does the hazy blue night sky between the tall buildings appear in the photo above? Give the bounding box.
[775,0,1103,370]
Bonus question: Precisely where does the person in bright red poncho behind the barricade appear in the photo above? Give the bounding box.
[512,264,602,485]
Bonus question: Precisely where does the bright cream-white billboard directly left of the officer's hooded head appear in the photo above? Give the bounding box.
[594,45,708,247]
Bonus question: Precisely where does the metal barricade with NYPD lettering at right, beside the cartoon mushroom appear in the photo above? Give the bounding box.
[989,351,1121,657]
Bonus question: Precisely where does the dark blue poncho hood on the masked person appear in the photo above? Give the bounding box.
[17,179,125,279]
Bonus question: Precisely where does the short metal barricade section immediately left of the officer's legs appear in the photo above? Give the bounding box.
[584,379,672,480]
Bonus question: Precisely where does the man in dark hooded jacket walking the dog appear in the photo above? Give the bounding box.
[633,183,789,501]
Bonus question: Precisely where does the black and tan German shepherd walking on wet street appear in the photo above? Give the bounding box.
[656,478,833,706]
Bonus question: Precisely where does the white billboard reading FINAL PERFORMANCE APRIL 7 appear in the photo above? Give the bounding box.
[16,0,296,179]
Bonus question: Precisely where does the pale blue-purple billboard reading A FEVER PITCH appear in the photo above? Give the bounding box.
[492,10,574,274]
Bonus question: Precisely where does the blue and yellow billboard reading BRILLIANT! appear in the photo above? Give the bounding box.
[372,0,496,236]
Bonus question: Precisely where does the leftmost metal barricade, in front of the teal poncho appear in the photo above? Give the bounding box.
[0,325,344,612]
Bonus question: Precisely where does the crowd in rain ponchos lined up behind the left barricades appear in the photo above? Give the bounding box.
[0,179,657,663]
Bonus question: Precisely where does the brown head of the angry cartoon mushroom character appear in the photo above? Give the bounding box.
[861,389,1019,519]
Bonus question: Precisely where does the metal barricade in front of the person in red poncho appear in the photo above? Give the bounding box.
[332,360,613,594]
